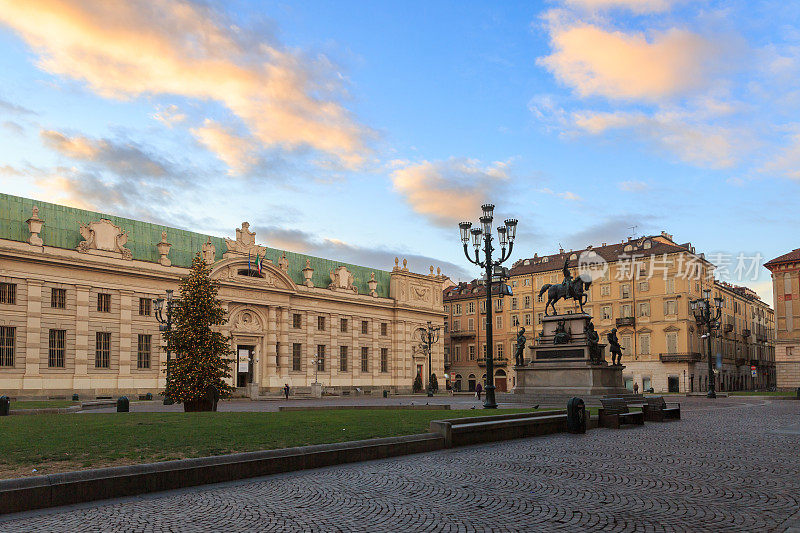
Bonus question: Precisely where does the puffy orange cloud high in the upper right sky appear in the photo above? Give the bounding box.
[537,17,721,101]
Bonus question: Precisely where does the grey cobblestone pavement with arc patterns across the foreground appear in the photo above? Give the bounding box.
[0,398,800,532]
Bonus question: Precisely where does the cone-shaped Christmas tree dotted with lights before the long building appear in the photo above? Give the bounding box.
[164,253,233,411]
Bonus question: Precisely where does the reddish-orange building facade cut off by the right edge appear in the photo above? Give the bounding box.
[764,248,800,389]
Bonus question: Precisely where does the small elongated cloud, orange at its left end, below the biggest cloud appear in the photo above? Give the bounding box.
[40,130,173,178]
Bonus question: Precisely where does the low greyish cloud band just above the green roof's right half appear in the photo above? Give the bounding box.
[253,226,475,280]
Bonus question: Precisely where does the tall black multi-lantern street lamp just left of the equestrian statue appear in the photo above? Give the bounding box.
[458,204,517,409]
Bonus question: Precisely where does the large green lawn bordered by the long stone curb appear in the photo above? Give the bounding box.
[0,408,544,479]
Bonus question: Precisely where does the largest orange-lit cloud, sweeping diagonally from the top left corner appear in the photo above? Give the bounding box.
[0,0,372,168]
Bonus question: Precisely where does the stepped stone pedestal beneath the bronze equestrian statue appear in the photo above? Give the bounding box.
[514,313,627,398]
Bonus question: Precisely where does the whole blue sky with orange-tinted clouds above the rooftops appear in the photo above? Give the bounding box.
[0,0,800,303]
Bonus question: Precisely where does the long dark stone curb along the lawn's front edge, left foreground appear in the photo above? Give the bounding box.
[0,433,444,514]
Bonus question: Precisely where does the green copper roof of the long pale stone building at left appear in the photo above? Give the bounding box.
[0,193,390,298]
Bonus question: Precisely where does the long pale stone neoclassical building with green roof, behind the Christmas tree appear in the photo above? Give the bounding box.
[0,194,447,397]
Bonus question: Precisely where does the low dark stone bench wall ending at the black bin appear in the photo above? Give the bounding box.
[430,410,567,448]
